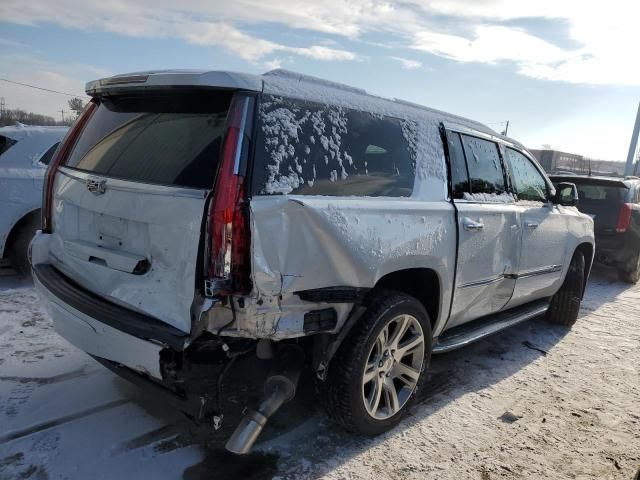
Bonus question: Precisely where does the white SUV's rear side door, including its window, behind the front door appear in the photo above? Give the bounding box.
[447,130,520,327]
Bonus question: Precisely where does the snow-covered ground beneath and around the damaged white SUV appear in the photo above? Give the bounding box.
[0,271,640,480]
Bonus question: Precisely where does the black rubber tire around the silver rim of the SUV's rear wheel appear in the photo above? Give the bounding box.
[319,291,432,435]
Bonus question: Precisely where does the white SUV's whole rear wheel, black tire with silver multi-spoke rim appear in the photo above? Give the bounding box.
[321,292,432,435]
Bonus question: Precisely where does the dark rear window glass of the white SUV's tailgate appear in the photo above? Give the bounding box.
[66,92,231,189]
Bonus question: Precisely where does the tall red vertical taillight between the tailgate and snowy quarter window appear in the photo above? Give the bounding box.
[209,97,251,294]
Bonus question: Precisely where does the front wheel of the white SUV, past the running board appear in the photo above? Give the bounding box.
[547,251,586,326]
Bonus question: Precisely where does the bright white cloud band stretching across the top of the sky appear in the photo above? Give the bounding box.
[0,0,640,85]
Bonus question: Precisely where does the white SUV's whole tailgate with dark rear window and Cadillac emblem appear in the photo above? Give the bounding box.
[50,90,232,332]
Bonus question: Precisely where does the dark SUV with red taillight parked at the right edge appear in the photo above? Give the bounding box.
[551,175,640,283]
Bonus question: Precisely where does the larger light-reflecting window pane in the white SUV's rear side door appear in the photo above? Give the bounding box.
[461,134,506,194]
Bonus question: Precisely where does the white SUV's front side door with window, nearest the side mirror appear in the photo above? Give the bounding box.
[505,148,571,307]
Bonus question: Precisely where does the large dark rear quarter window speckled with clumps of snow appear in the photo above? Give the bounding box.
[253,95,417,197]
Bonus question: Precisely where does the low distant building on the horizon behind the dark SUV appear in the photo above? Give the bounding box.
[529,150,624,177]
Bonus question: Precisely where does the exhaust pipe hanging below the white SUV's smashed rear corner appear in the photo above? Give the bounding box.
[225,345,304,455]
